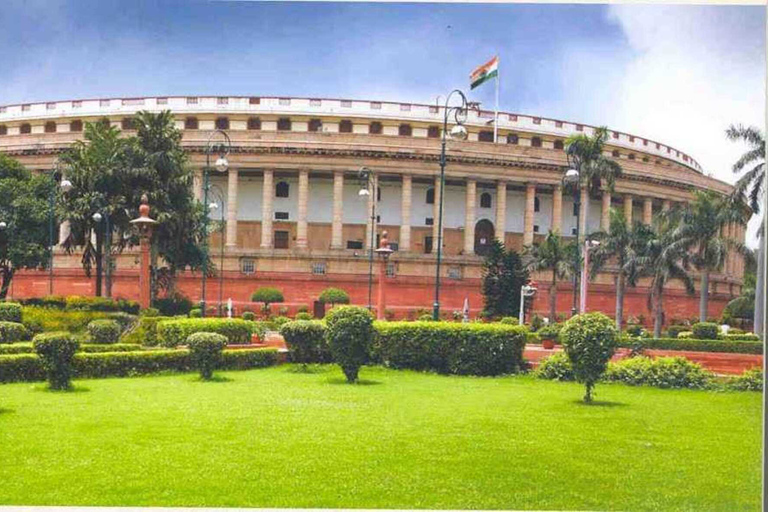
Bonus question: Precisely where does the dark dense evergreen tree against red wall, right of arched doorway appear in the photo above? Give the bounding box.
[482,240,528,318]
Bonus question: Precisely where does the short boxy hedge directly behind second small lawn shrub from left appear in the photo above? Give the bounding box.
[157,318,255,347]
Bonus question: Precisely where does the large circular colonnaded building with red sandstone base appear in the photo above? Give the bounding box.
[0,96,744,320]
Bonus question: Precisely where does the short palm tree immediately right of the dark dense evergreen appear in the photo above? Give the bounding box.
[523,230,576,322]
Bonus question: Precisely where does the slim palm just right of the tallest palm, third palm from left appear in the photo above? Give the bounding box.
[590,209,653,331]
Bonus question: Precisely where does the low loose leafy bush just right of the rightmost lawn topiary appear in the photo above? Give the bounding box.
[605,357,712,389]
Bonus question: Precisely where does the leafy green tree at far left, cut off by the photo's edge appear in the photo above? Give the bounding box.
[0,154,55,300]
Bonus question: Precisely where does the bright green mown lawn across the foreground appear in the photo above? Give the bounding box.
[0,366,761,511]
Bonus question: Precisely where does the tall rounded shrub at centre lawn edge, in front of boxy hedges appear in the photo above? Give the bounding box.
[326,306,373,383]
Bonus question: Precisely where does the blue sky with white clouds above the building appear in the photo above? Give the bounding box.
[0,0,765,240]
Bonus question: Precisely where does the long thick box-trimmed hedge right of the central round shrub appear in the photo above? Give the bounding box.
[373,322,528,375]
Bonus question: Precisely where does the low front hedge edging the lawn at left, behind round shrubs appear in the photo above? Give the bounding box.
[0,345,277,383]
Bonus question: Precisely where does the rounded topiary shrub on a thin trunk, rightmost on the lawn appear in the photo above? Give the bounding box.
[560,313,618,403]
